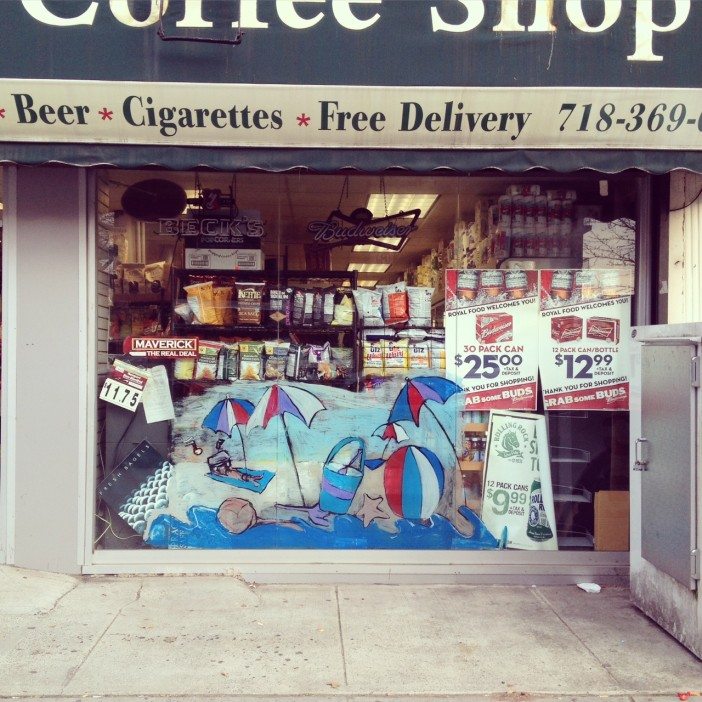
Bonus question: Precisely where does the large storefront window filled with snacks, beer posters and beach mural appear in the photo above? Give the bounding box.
[95,171,637,550]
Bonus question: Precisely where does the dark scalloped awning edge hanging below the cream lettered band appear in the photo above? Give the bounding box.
[0,143,702,174]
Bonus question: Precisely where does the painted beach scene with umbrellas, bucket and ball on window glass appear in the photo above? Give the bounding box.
[136,374,503,549]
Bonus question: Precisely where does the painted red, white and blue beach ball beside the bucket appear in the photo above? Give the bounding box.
[383,446,444,519]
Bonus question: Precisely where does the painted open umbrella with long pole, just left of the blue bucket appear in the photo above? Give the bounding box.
[246,383,326,505]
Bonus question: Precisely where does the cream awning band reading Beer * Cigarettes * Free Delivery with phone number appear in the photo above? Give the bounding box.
[0,80,702,150]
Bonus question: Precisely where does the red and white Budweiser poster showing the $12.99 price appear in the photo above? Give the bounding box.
[539,268,633,411]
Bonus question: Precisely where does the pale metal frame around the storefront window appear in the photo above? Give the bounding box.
[80,169,654,584]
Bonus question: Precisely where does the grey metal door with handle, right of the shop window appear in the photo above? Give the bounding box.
[631,324,702,657]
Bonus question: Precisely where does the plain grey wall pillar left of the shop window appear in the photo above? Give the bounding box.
[2,167,86,573]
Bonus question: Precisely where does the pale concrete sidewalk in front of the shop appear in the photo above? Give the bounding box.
[0,567,702,702]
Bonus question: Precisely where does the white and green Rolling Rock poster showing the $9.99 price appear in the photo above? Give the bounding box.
[481,412,558,551]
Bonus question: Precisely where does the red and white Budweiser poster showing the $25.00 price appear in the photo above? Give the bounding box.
[444,268,539,411]
